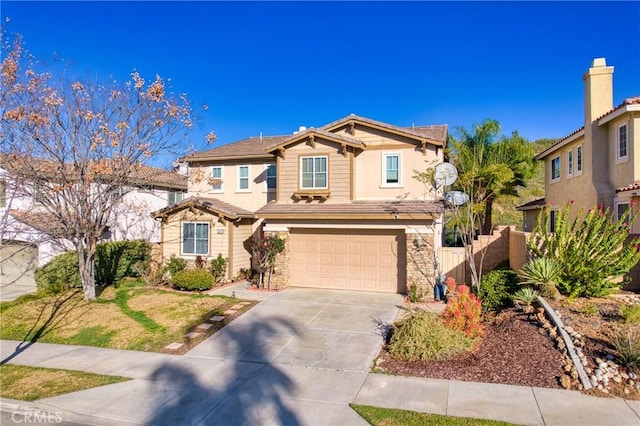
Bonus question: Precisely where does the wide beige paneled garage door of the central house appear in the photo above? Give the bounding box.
[290,229,405,293]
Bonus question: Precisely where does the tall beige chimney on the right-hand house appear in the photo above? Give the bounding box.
[582,58,613,126]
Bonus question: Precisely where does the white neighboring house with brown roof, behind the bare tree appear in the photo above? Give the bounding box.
[0,165,187,284]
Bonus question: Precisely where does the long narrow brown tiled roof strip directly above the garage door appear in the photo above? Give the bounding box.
[256,200,443,219]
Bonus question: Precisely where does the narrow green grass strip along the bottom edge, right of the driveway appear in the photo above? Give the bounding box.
[351,404,511,426]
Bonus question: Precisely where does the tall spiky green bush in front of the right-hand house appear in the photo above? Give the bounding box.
[529,202,640,297]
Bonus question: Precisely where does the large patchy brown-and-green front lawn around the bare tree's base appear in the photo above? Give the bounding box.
[0,286,247,352]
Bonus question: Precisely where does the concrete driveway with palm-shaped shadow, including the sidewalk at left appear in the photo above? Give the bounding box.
[12,287,402,425]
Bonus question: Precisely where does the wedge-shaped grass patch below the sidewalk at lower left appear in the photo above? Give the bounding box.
[0,364,130,401]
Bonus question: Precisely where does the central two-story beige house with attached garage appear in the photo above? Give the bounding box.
[154,115,447,293]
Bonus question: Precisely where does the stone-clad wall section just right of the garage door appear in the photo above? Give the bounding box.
[408,234,436,299]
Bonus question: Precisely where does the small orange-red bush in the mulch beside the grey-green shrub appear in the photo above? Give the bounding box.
[442,284,483,338]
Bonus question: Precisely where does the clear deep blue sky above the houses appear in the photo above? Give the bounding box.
[0,0,640,165]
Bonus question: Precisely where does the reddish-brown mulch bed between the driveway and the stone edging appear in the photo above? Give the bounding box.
[378,309,563,388]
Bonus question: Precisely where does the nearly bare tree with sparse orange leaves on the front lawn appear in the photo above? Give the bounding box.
[0,29,192,299]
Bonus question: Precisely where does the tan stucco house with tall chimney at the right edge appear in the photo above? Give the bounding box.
[518,58,640,234]
